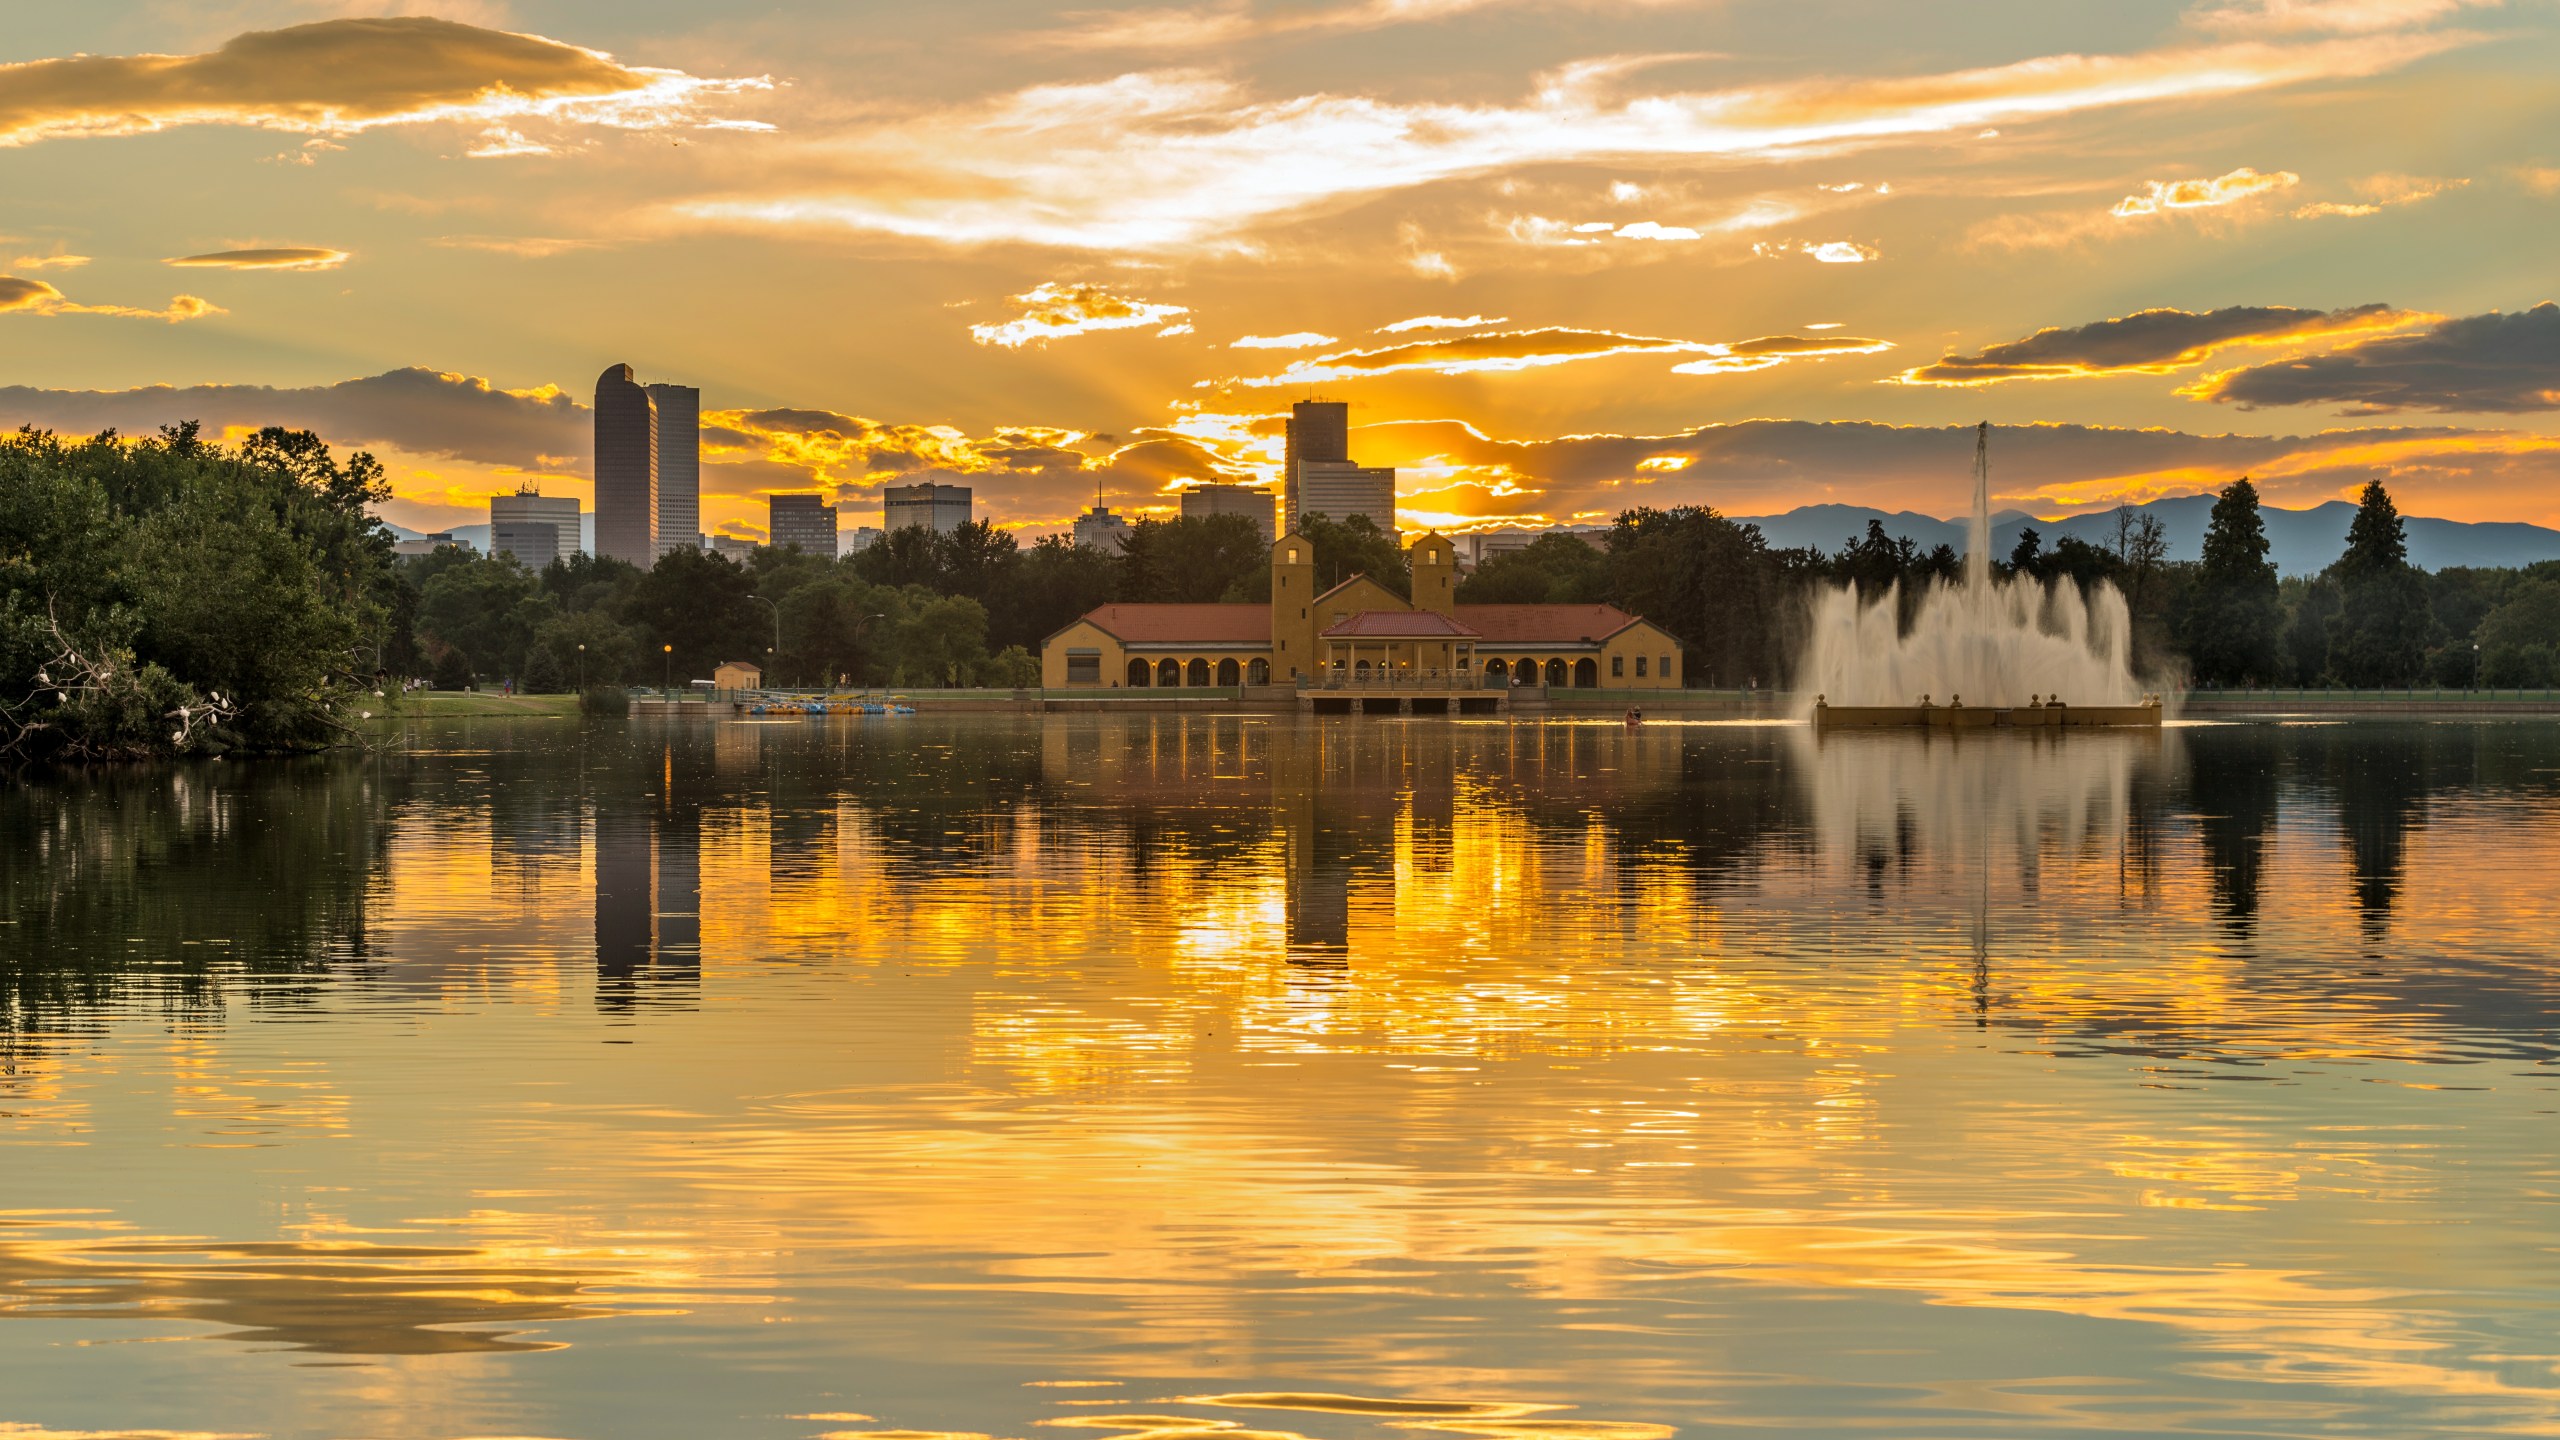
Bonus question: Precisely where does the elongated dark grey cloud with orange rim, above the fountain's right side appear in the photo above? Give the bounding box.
[1897,305,2437,384]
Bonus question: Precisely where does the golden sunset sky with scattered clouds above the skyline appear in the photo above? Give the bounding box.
[0,0,2560,536]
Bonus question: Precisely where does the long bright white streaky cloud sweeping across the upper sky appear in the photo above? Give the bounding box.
[676,31,2473,251]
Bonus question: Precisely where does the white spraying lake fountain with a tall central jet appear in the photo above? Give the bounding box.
[1797,423,2161,730]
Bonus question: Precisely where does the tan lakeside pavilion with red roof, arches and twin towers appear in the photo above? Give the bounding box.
[1039,533,1679,689]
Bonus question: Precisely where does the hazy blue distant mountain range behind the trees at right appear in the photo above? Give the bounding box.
[1733,495,2560,574]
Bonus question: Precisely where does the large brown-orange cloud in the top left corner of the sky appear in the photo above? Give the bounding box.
[0,15,771,146]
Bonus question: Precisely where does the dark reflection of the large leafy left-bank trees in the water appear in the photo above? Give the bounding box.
[0,756,389,1033]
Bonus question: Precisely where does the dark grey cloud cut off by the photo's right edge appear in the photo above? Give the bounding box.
[2181,300,2560,415]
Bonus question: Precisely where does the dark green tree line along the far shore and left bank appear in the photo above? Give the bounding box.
[0,415,2560,758]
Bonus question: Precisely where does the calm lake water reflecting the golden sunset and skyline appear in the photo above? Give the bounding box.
[0,715,2560,1440]
